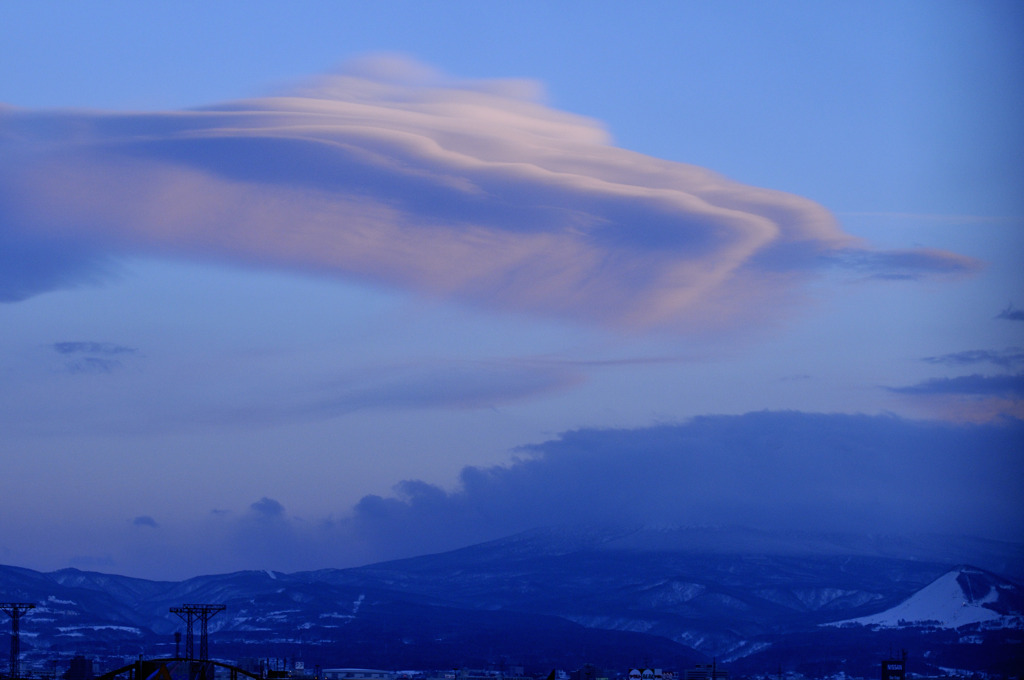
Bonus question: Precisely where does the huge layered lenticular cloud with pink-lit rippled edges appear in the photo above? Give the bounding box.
[0,59,972,328]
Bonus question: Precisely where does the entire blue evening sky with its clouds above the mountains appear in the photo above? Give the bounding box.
[0,0,1024,579]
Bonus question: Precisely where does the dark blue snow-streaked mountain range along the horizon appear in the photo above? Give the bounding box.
[0,526,1024,677]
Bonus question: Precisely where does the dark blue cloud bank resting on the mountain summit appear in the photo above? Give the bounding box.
[193,412,1024,570]
